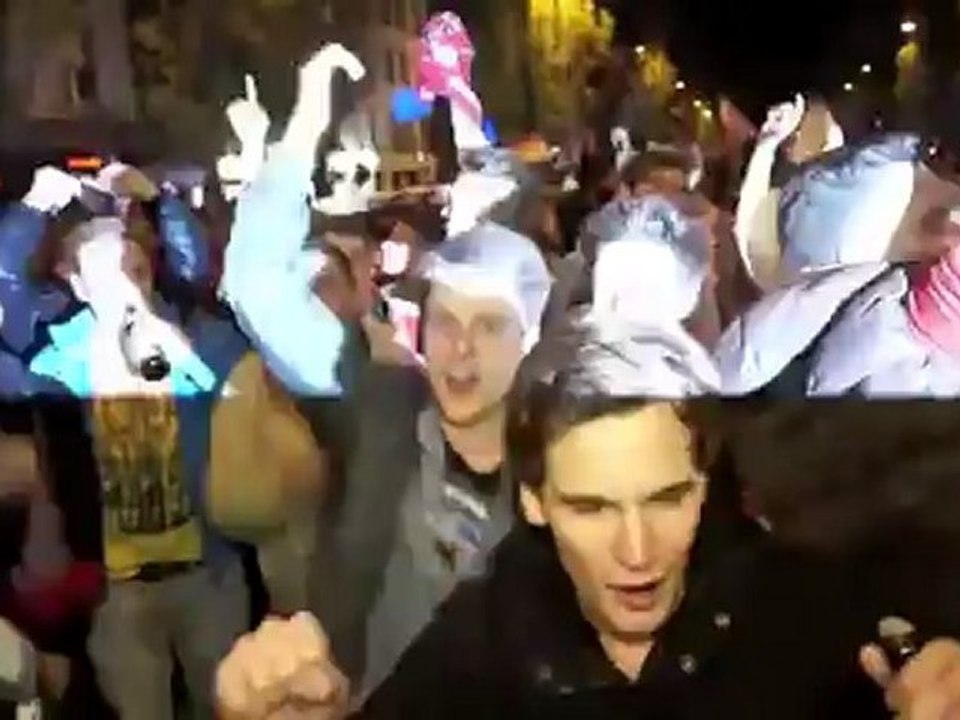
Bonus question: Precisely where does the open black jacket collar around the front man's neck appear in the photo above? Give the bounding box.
[495,526,756,696]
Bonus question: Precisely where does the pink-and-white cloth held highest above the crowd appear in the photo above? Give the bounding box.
[417,12,483,127]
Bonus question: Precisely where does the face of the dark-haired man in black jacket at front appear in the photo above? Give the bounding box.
[522,403,706,647]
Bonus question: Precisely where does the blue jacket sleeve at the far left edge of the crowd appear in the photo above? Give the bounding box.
[0,203,70,353]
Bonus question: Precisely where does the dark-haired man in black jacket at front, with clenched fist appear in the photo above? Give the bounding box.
[218,325,960,720]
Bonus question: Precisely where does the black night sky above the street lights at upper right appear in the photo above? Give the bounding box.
[605,0,960,117]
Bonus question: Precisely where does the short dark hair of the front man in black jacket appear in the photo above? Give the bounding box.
[506,322,719,490]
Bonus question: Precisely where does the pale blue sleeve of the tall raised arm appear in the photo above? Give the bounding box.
[220,151,345,397]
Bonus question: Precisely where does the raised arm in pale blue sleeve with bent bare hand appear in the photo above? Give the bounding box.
[220,45,364,396]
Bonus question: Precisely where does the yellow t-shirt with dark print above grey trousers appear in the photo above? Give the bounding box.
[92,397,202,580]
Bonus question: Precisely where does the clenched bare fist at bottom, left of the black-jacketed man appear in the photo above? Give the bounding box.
[216,613,348,720]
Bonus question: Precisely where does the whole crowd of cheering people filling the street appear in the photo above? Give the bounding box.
[0,13,960,720]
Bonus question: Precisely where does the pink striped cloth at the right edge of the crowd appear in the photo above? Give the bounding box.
[907,245,960,356]
